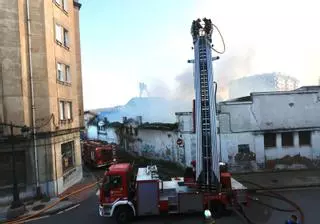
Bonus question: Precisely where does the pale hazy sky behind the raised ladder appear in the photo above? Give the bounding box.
[80,0,320,109]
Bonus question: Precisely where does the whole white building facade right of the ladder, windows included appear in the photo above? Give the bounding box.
[218,86,320,171]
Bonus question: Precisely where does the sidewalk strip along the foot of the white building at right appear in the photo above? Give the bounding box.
[232,170,320,190]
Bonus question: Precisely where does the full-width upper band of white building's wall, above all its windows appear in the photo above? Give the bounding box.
[218,91,320,133]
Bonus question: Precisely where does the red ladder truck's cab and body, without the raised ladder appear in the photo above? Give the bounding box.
[99,163,246,224]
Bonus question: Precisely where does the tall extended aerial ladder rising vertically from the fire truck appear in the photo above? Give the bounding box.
[189,18,220,188]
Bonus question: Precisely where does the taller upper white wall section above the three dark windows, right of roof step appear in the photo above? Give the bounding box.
[253,93,320,130]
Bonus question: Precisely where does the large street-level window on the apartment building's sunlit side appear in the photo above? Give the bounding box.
[61,141,75,173]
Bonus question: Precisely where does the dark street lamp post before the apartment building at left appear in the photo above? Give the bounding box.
[0,122,30,209]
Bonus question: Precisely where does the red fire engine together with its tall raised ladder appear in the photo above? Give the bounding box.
[99,19,247,224]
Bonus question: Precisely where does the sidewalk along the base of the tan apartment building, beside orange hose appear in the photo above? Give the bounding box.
[0,167,97,223]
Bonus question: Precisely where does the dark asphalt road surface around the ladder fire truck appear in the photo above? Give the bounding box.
[29,189,320,224]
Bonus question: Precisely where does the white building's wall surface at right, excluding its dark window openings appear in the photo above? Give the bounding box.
[218,91,320,170]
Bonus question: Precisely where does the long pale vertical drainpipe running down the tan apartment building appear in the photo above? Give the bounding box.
[26,0,41,197]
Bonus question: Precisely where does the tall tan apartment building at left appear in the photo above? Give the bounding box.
[0,0,84,200]
